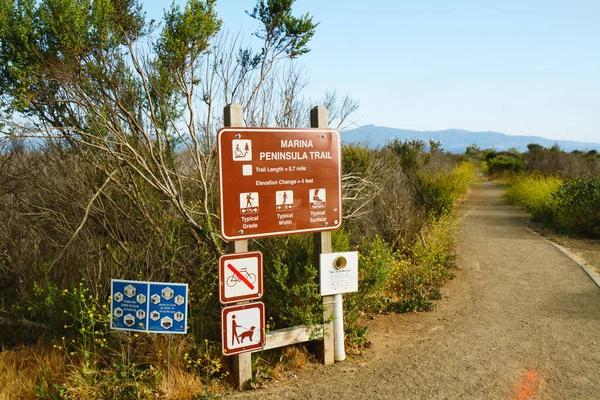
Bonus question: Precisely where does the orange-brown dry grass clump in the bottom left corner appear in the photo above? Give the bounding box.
[0,343,68,400]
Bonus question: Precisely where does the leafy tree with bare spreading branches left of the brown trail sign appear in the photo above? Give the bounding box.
[0,0,316,260]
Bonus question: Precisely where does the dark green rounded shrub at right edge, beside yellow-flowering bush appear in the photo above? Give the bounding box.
[553,176,600,237]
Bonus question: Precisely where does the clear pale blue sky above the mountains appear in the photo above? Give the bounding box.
[145,0,600,142]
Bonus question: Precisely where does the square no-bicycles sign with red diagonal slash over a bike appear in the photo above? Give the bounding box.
[219,251,263,304]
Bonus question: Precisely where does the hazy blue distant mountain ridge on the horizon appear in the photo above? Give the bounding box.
[342,125,600,153]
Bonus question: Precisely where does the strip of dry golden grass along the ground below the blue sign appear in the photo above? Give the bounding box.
[0,338,224,400]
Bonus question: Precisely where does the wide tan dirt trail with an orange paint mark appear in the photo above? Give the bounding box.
[226,183,600,400]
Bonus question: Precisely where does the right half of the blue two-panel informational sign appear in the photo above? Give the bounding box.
[148,282,187,333]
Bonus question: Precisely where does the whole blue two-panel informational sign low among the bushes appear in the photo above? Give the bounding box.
[110,279,188,333]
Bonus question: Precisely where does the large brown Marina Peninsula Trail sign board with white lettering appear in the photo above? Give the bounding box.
[217,128,342,241]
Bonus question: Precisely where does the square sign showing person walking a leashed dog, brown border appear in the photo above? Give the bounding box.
[221,302,265,355]
